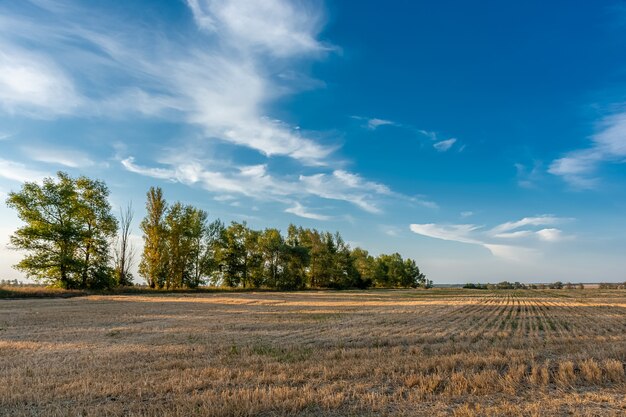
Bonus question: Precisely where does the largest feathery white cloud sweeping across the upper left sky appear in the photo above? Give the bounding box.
[0,0,333,165]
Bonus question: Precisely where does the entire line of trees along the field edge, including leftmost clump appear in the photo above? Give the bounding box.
[7,172,432,290]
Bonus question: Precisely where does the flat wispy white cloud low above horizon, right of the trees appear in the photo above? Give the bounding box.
[410,215,573,261]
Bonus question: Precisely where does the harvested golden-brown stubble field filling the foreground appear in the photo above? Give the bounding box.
[0,289,626,416]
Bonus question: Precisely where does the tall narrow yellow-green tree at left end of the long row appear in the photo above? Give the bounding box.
[139,187,168,288]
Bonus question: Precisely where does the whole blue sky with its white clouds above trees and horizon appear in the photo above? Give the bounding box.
[0,0,626,283]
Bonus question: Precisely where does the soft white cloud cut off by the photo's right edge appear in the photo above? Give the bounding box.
[548,112,626,189]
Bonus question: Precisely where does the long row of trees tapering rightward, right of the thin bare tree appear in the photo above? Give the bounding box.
[139,187,429,290]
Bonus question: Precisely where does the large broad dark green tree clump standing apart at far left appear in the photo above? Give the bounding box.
[7,172,117,288]
